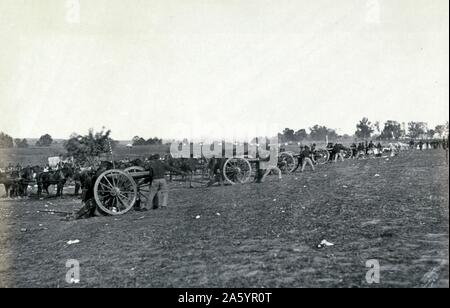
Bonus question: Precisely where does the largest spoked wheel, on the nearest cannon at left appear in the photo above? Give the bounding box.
[94,170,138,215]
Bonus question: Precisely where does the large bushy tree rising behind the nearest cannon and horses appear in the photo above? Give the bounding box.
[64,129,117,163]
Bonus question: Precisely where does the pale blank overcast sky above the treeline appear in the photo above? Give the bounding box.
[0,0,449,140]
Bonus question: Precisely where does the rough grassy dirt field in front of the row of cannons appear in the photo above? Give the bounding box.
[0,150,449,287]
